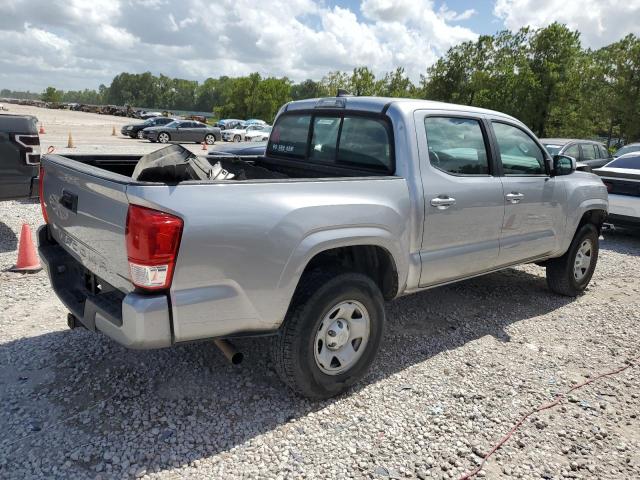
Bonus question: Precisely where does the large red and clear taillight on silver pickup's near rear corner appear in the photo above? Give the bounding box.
[126,205,183,290]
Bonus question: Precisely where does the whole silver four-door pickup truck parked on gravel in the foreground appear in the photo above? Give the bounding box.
[39,97,608,398]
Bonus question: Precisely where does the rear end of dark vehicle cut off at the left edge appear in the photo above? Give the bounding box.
[0,114,40,200]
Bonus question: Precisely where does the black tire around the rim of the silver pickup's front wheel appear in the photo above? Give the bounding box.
[547,223,600,297]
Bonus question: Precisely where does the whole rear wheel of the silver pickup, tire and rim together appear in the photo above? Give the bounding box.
[271,271,385,399]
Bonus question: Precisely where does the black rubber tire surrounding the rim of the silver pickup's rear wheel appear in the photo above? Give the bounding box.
[271,270,385,399]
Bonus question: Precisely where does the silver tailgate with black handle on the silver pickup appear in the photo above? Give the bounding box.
[42,155,133,292]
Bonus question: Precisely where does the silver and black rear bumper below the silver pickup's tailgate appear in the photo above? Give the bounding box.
[38,225,173,349]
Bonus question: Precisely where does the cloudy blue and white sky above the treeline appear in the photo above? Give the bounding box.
[0,0,640,91]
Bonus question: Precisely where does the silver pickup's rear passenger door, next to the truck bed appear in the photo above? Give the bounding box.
[415,111,504,286]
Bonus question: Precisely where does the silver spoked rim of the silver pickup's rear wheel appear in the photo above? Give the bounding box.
[313,300,371,375]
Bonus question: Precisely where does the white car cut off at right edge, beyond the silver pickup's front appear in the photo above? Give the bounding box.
[593,151,640,228]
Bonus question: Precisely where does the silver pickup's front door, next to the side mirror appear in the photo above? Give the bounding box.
[491,120,566,265]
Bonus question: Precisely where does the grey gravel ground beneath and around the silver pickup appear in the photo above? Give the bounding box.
[0,202,640,479]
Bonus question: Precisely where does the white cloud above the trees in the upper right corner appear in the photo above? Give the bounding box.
[494,0,640,48]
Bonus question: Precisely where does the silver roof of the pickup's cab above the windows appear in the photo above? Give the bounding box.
[284,96,519,122]
